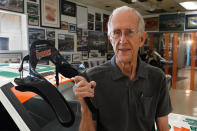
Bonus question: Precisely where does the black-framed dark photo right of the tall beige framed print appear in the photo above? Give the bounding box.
[61,0,76,17]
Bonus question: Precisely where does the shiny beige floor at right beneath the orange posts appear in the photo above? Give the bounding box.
[170,67,197,117]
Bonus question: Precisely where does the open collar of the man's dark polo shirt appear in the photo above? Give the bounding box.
[111,55,148,80]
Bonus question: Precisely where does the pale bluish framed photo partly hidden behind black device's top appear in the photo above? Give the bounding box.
[28,28,45,45]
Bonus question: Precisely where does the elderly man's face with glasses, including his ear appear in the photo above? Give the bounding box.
[108,11,146,64]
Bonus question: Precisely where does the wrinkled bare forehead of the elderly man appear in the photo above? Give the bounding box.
[111,10,139,30]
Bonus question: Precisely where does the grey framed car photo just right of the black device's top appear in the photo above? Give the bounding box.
[58,34,74,52]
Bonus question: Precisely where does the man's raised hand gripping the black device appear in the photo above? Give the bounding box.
[73,76,96,108]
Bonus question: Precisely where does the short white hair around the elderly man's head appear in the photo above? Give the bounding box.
[107,6,145,35]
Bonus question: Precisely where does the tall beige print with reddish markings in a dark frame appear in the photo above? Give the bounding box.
[40,0,61,28]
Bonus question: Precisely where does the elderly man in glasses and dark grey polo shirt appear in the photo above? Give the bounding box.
[73,6,172,131]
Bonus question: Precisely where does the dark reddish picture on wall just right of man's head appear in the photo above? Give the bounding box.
[144,17,159,31]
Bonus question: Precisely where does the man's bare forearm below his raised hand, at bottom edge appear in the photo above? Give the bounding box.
[79,106,96,131]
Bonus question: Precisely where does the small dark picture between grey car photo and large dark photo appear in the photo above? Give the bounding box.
[77,36,88,51]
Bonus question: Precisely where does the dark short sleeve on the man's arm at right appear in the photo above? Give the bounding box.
[156,76,172,117]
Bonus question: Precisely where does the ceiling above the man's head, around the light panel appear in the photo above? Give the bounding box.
[73,0,196,15]
